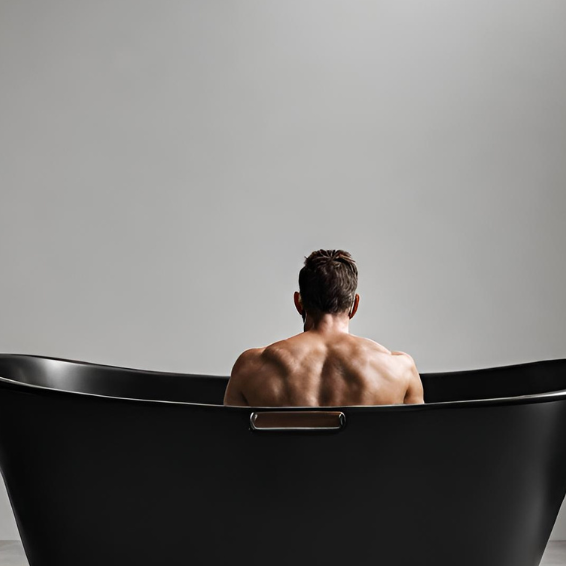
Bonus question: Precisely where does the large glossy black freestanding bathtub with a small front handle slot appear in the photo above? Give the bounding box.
[0,355,566,566]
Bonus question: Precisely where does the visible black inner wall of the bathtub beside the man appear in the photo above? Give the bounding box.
[0,354,566,405]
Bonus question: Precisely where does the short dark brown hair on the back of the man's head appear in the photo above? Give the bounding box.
[299,250,358,316]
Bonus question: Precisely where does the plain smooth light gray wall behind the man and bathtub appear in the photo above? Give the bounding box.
[0,0,566,539]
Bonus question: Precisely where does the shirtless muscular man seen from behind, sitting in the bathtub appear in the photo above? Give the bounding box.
[224,250,424,407]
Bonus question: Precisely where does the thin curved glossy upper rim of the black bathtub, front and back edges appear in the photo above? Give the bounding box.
[0,353,566,412]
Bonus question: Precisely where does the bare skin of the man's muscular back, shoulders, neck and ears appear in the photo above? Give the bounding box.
[224,292,424,407]
